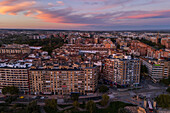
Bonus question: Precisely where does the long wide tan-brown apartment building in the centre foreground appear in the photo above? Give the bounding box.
[29,66,98,95]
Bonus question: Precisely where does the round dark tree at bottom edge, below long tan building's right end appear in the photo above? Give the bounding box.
[86,100,96,113]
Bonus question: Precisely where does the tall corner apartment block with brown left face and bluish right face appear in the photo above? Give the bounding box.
[104,54,140,86]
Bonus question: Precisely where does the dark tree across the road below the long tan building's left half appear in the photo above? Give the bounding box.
[45,99,57,110]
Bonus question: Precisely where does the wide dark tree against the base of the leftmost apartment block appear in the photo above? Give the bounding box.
[2,86,19,95]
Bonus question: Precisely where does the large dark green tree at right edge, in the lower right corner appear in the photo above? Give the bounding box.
[155,94,170,108]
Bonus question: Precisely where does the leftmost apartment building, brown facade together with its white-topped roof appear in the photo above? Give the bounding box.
[0,60,32,94]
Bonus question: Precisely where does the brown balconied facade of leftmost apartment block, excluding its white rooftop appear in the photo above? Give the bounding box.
[0,68,29,94]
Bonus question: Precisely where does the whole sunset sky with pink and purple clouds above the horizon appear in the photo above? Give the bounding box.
[0,0,170,30]
